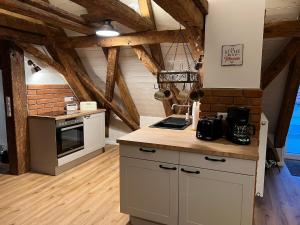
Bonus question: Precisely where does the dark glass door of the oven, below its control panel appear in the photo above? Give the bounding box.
[57,123,84,158]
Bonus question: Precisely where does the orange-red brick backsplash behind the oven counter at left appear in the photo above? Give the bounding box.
[27,85,75,115]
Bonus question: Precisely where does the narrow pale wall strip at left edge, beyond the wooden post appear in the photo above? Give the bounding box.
[0,70,7,146]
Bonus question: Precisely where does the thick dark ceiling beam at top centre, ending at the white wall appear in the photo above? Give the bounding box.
[154,0,204,30]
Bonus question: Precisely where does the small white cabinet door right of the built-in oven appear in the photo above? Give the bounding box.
[84,113,105,153]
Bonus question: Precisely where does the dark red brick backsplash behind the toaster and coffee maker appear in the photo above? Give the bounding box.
[201,88,262,137]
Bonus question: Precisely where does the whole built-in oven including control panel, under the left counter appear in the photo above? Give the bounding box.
[56,117,84,158]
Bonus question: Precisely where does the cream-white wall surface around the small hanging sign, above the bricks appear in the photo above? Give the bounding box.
[204,0,265,88]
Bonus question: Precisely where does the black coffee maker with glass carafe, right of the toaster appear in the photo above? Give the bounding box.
[226,107,255,145]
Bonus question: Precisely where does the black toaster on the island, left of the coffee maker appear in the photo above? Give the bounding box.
[196,116,223,141]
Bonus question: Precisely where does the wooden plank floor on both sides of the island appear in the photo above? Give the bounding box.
[0,146,300,225]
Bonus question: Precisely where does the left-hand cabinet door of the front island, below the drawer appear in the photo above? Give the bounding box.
[120,157,178,225]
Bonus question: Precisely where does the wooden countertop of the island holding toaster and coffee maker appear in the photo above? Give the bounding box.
[117,126,258,161]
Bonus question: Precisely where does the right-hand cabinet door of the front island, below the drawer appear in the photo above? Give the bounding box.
[179,167,254,225]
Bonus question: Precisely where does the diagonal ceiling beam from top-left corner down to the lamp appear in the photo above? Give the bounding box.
[0,0,95,34]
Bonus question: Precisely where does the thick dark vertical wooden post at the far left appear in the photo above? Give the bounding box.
[0,41,29,174]
